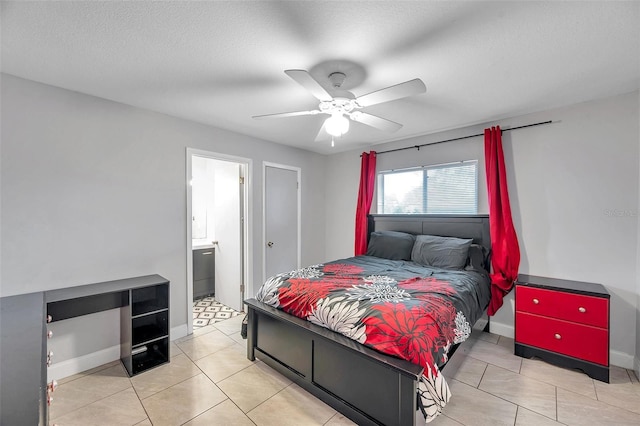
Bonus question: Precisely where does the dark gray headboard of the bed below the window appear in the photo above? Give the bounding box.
[369,214,491,250]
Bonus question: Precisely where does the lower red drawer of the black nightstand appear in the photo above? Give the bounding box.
[515,312,609,366]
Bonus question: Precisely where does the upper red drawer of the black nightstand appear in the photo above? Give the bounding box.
[516,285,609,328]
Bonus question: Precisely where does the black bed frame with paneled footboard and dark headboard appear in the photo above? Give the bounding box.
[244,215,491,426]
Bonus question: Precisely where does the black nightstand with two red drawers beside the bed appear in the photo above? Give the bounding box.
[515,275,610,383]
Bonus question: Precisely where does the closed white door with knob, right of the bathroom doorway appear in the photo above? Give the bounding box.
[264,166,299,279]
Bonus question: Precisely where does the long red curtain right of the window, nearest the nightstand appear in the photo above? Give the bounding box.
[484,126,520,315]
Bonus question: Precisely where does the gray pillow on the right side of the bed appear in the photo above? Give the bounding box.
[411,235,473,269]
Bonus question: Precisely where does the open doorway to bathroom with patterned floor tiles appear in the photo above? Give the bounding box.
[187,149,251,333]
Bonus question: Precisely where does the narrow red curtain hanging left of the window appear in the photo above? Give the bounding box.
[355,151,376,256]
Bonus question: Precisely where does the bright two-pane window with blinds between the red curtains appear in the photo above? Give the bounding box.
[378,160,478,214]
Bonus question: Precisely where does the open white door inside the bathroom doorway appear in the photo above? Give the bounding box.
[209,160,243,311]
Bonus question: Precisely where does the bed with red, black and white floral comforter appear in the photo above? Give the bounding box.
[245,215,491,425]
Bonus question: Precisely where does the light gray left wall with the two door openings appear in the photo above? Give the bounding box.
[0,74,325,372]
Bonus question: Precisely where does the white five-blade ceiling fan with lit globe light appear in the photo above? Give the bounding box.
[253,70,427,143]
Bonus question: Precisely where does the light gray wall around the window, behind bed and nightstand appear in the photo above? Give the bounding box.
[325,92,640,367]
